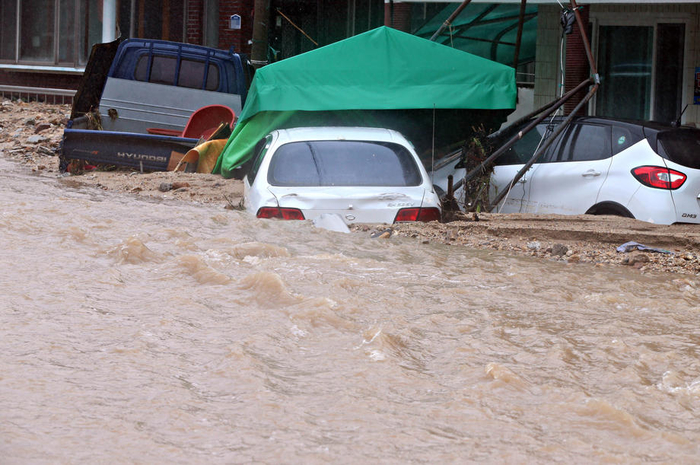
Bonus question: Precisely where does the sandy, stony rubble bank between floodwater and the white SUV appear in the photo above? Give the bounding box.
[354,213,700,276]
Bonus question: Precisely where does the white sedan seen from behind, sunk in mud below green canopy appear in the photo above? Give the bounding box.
[243,127,440,224]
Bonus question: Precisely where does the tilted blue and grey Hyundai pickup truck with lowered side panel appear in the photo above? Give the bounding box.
[61,39,252,171]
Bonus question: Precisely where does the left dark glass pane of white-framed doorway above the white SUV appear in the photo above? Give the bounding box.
[596,26,654,120]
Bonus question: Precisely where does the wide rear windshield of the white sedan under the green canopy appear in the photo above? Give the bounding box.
[268,140,422,187]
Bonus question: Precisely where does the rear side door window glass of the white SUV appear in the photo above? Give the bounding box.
[552,124,612,161]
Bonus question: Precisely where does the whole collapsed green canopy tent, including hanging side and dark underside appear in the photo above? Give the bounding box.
[214,27,517,177]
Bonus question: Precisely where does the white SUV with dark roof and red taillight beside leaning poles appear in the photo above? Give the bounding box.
[435,117,700,224]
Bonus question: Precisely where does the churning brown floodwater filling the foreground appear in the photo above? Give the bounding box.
[0,160,700,464]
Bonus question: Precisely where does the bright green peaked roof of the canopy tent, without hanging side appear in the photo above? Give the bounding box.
[240,27,517,121]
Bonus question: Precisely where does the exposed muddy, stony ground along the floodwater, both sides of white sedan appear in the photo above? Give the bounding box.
[0,100,700,275]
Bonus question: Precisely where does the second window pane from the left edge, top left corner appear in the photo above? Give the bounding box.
[19,0,56,62]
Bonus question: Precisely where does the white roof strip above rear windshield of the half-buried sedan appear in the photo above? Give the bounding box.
[271,126,408,144]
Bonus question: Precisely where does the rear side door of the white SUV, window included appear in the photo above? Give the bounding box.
[529,122,612,214]
